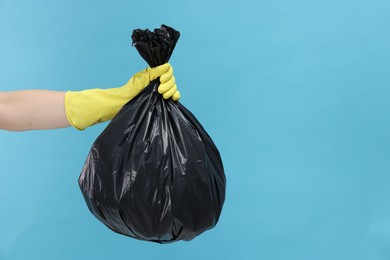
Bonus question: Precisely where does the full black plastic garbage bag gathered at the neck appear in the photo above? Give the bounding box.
[79,25,226,243]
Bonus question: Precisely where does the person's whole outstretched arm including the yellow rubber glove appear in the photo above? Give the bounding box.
[0,63,180,131]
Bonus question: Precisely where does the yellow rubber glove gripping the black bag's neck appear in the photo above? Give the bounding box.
[65,63,180,130]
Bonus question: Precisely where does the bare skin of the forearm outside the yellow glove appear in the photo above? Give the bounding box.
[0,90,70,131]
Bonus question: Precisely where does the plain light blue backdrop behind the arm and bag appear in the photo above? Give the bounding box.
[0,0,390,260]
